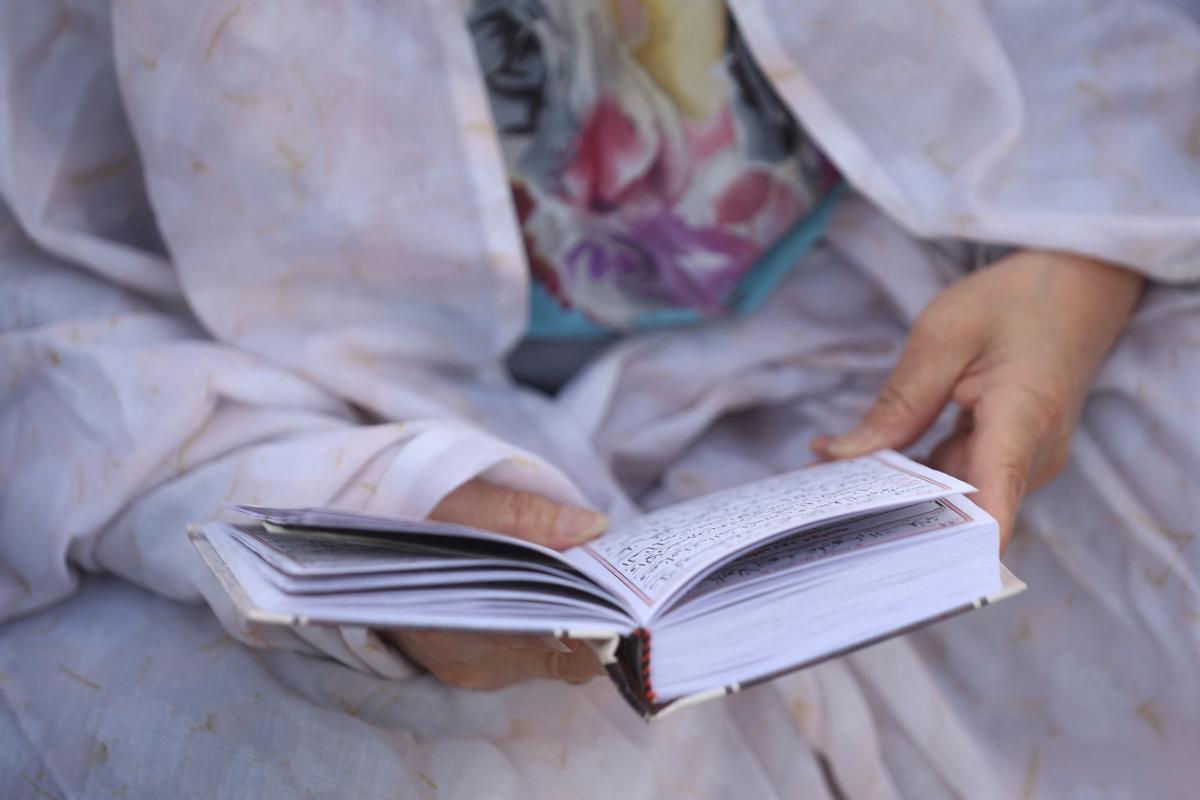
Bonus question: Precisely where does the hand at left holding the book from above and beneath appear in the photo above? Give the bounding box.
[384,480,608,690]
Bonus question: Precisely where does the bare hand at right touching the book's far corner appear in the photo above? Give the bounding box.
[812,251,1142,552]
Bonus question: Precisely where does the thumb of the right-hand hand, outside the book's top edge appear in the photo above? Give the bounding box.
[814,325,967,458]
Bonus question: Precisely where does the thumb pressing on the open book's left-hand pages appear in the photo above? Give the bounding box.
[430,480,608,549]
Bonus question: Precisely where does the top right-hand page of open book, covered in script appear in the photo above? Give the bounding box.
[566,451,974,613]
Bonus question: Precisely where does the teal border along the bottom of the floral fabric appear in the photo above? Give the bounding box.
[526,181,845,339]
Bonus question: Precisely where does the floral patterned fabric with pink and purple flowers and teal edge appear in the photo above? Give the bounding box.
[467,0,838,337]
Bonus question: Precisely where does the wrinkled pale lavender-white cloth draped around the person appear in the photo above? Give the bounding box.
[0,0,1200,799]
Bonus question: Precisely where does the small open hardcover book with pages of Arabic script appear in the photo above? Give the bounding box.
[191,451,1024,718]
